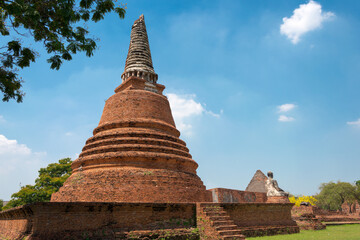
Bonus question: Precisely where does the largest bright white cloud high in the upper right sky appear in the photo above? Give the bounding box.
[280,0,335,44]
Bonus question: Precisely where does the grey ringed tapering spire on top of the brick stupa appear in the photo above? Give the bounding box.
[121,15,158,83]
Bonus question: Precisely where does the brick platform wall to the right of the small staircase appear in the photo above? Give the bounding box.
[220,203,296,227]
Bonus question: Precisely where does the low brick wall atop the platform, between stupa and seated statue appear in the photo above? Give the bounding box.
[208,188,267,203]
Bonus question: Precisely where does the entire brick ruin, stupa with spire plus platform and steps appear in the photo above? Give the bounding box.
[0,16,299,240]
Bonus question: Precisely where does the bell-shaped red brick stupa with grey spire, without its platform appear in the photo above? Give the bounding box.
[51,16,208,202]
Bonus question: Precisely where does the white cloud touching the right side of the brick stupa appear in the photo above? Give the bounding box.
[166,93,220,135]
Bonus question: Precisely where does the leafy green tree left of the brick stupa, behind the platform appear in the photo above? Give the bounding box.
[3,158,72,209]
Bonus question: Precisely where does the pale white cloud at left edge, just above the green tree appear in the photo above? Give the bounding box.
[0,135,46,200]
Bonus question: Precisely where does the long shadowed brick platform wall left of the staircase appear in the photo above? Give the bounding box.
[0,202,196,239]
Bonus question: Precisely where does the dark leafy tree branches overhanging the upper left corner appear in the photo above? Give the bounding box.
[0,0,126,102]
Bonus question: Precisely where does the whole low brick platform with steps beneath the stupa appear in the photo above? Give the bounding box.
[0,202,299,240]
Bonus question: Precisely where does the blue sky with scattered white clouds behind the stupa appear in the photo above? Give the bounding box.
[0,0,360,200]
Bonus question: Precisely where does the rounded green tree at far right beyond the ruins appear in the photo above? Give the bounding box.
[316,182,356,210]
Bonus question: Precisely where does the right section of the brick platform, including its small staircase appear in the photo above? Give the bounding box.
[197,203,299,239]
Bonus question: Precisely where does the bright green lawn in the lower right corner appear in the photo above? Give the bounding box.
[246,224,360,240]
